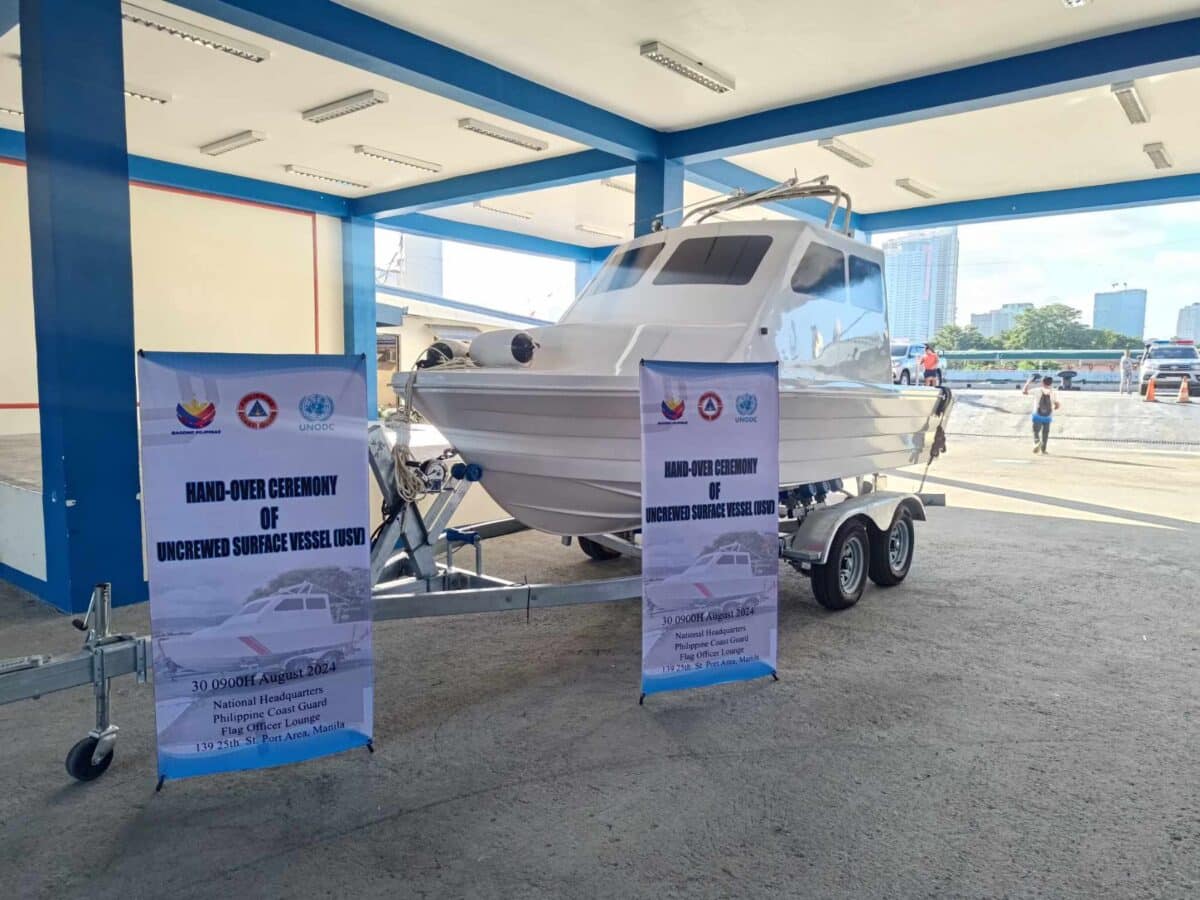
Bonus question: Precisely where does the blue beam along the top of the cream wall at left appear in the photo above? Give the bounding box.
[0,128,350,218]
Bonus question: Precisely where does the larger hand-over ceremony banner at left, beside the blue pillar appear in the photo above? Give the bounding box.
[138,353,373,779]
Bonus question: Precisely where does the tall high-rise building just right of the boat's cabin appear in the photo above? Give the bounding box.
[883,228,959,341]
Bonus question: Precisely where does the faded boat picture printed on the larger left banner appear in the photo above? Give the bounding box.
[158,583,368,672]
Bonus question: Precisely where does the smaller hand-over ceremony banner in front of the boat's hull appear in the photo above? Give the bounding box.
[641,360,779,694]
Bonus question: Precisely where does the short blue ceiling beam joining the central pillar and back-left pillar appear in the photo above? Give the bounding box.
[352,150,632,218]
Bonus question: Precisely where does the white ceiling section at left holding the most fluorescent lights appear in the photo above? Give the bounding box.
[0,0,584,197]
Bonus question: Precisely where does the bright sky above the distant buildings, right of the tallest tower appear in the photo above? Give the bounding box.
[956,203,1200,337]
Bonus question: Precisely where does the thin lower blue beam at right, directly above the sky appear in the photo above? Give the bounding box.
[858,175,1200,233]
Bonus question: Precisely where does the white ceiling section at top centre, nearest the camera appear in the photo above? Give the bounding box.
[337,0,1200,131]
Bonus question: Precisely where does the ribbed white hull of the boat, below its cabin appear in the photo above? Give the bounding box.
[414,370,948,535]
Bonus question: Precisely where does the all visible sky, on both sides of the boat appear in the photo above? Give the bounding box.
[380,202,1200,337]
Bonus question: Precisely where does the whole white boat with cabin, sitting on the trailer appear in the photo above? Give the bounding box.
[408,181,950,535]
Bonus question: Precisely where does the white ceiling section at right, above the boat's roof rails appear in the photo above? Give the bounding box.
[730,70,1200,212]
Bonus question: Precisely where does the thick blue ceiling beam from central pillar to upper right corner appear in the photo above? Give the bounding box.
[662,18,1200,166]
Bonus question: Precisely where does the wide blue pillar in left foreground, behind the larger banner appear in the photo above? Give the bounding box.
[20,0,146,612]
